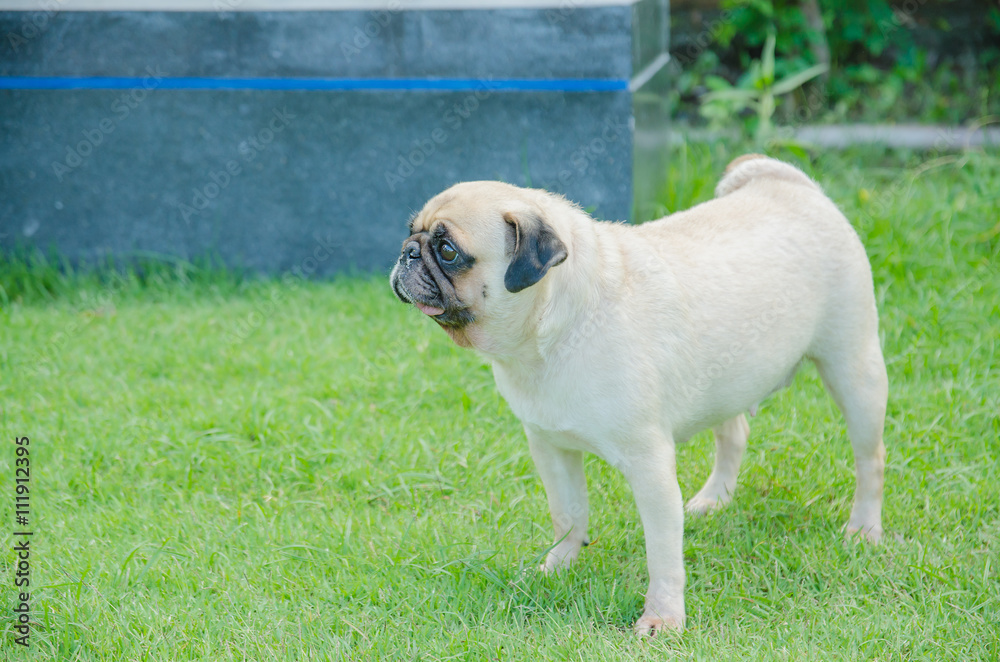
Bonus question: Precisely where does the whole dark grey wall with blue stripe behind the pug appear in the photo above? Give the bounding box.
[0,3,672,275]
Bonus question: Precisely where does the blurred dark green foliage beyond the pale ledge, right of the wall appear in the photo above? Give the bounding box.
[671,0,1000,125]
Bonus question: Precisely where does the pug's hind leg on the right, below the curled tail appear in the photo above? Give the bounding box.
[816,338,889,542]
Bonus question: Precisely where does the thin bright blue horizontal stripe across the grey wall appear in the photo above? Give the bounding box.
[0,76,628,92]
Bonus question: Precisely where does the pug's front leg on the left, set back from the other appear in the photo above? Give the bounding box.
[524,426,588,572]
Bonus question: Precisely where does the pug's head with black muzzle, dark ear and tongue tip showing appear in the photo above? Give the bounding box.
[390,182,567,351]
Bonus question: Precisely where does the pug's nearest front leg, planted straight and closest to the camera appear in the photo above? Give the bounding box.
[621,436,684,635]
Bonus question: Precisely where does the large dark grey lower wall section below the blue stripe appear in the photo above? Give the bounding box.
[0,89,632,275]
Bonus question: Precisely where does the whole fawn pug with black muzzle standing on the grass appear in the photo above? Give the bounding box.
[391,154,888,635]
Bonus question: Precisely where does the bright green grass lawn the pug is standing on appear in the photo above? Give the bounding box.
[0,145,1000,660]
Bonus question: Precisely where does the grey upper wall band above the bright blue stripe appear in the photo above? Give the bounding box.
[0,6,631,78]
